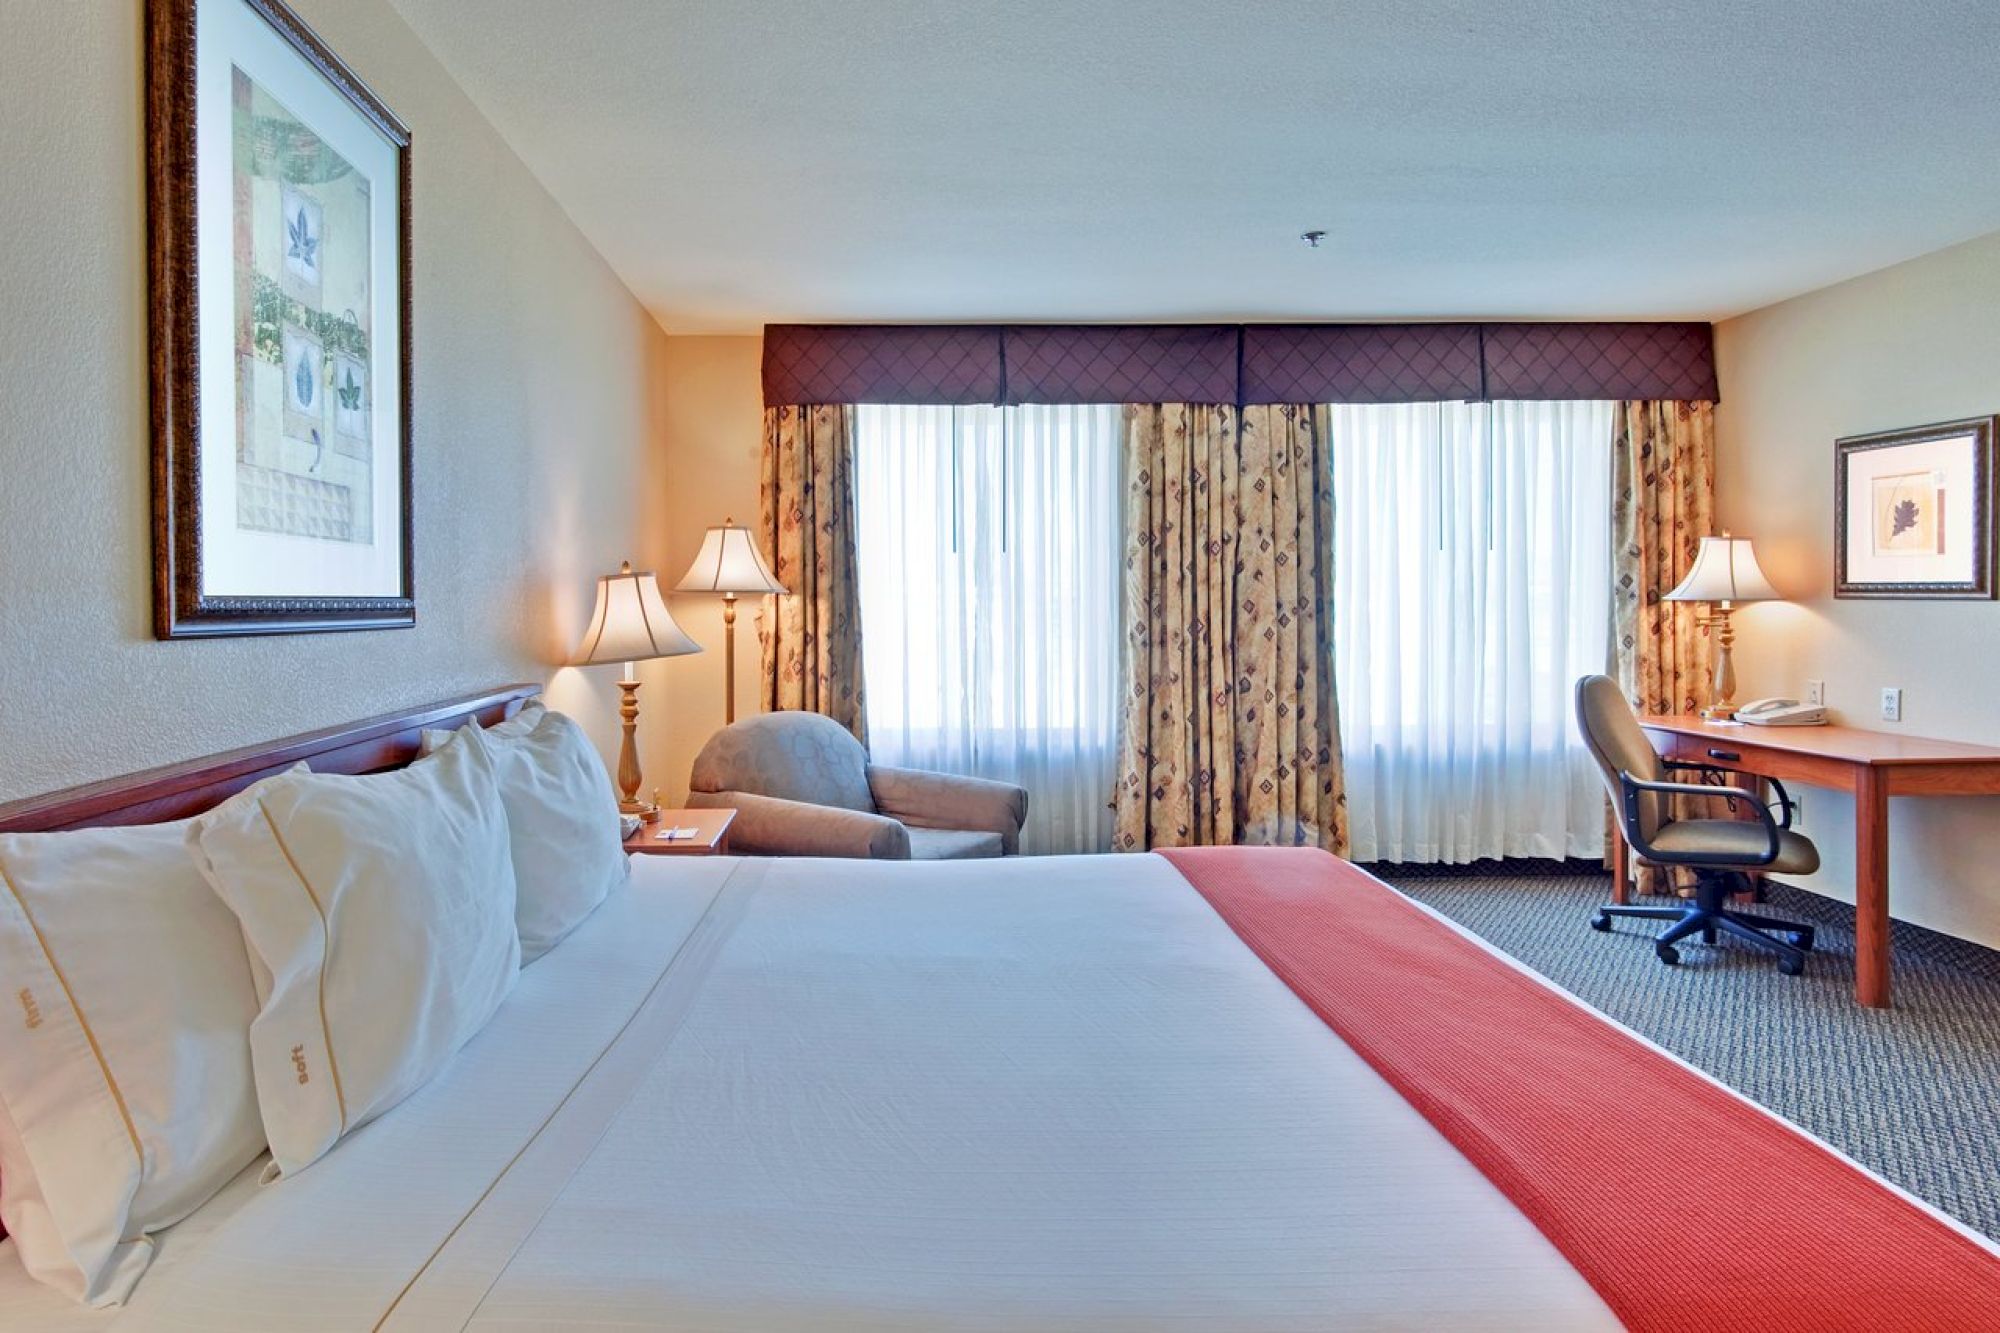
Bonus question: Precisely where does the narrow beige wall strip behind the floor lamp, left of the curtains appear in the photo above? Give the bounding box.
[652,334,770,801]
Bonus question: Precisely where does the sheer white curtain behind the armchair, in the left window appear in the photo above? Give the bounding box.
[854,406,1120,853]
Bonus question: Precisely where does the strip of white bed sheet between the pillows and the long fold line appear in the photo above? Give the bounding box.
[0,861,734,1333]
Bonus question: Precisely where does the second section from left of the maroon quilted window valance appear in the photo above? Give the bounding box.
[1002,324,1238,402]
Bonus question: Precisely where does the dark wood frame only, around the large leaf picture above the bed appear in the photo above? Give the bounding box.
[146,0,416,638]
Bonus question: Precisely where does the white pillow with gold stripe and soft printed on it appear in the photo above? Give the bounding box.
[188,747,520,1175]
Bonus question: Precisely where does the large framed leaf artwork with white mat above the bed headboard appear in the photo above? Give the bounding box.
[146,0,416,638]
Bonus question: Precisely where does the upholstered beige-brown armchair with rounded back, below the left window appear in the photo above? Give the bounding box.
[688,713,1028,861]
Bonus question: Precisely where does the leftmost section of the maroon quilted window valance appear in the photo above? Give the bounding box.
[764,324,1000,406]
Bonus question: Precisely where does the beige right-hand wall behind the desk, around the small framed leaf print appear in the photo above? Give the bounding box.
[1716,234,2000,947]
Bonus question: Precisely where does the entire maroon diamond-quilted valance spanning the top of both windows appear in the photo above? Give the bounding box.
[764,324,1720,406]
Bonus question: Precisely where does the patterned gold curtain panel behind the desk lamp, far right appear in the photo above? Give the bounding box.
[1612,400,1716,893]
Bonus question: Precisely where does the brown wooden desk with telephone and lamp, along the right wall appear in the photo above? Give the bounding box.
[1612,715,2000,1009]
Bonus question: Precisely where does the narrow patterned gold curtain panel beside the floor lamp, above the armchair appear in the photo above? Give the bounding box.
[758,406,868,745]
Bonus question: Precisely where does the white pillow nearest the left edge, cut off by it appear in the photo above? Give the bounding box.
[0,823,264,1305]
